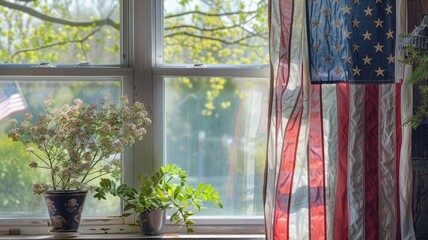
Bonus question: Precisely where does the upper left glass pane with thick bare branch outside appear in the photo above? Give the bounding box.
[0,0,120,64]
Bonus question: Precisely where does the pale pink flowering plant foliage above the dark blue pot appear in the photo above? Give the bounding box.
[8,96,151,194]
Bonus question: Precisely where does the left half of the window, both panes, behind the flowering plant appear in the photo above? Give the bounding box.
[0,0,127,223]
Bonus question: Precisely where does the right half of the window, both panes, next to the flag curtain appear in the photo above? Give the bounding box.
[154,0,269,218]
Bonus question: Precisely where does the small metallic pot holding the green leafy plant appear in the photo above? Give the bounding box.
[139,209,166,235]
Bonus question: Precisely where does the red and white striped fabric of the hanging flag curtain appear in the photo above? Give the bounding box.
[264,0,414,240]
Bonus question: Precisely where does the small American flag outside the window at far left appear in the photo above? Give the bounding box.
[0,82,27,121]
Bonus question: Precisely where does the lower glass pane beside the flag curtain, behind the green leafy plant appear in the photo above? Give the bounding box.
[164,77,269,216]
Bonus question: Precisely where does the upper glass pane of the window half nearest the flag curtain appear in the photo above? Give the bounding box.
[163,0,268,64]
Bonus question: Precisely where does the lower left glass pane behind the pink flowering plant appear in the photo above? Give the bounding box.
[0,77,122,217]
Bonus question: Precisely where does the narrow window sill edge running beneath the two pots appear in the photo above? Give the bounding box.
[0,234,265,240]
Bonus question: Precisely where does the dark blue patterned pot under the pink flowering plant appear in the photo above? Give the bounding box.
[43,191,88,232]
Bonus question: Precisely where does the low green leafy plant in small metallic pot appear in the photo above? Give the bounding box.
[94,165,223,235]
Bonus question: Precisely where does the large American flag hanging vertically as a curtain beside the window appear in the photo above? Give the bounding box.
[264,0,414,240]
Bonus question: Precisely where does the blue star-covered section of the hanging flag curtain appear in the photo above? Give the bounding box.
[307,0,396,83]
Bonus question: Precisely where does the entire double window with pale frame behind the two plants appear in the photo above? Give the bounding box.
[0,0,269,233]
